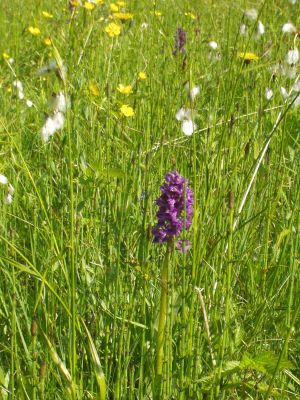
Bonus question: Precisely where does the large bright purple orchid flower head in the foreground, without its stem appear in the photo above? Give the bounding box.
[152,171,194,243]
